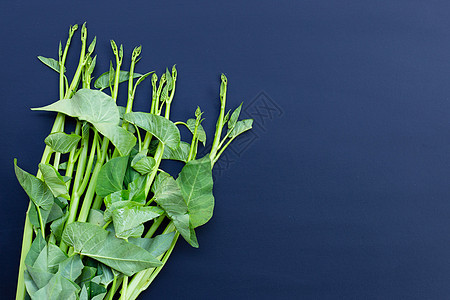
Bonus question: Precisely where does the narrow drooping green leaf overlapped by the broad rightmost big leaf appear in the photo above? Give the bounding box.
[152,173,198,247]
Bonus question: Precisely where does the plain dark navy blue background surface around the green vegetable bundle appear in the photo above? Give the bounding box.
[0,0,450,299]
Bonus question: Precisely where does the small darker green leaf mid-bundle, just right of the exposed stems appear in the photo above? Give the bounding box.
[95,156,128,197]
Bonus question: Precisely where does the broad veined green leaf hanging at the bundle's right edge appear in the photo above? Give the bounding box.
[177,155,214,228]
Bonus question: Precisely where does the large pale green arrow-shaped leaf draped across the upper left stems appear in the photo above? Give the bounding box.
[33,89,136,155]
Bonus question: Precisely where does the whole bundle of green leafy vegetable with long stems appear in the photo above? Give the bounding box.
[14,25,252,300]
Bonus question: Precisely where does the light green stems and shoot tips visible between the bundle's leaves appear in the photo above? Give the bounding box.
[16,25,232,300]
